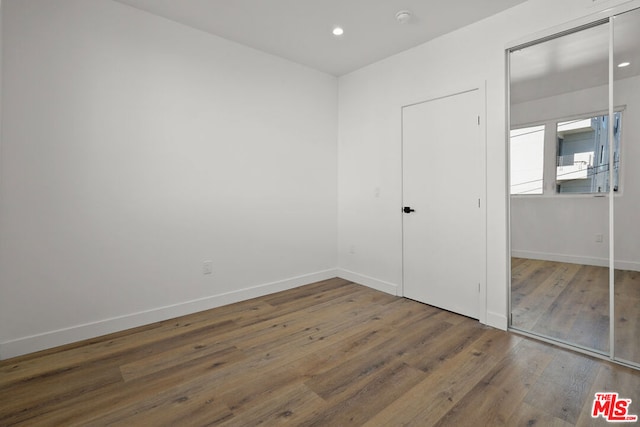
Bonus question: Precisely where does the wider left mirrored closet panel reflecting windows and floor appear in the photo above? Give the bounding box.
[509,22,620,354]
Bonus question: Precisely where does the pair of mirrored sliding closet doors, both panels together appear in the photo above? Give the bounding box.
[508,5,640,363]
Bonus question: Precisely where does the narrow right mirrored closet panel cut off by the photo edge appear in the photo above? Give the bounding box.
[611,9,640,365]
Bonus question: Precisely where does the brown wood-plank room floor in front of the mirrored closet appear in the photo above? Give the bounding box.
[0,279,640,426]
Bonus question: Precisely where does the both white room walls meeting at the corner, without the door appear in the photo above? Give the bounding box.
[0,0,640,357]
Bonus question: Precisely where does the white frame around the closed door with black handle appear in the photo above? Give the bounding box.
[398,80,488,324]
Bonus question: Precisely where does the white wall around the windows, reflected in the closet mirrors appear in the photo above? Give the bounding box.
[511,77,640,271]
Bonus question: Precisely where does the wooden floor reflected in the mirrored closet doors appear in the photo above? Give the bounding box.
[511,258,640,363]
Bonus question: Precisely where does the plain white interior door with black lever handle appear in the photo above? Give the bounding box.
[402,90,486,319]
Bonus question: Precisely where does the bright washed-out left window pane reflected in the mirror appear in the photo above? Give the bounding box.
[510,125,544,194]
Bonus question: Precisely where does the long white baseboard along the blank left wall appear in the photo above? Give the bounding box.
[0,269,339,360]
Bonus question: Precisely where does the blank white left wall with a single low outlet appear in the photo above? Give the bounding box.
[0,0,337,358]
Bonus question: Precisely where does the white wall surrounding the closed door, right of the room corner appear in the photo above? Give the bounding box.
[338,0,640,328]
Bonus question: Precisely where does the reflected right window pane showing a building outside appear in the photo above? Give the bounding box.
[556,113,620,193]
